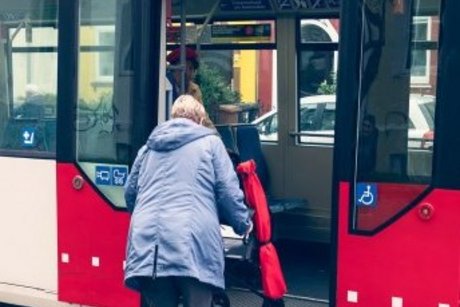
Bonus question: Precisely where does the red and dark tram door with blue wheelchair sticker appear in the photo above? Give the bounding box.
[331,0,460,307]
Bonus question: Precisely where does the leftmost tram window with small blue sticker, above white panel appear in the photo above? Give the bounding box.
[0,1,58,157]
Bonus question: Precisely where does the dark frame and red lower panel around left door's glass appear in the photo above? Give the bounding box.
[56,0,165,306]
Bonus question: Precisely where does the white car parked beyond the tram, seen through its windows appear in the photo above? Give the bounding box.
[252,94,435,149]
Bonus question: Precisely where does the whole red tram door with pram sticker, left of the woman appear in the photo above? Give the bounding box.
[57,0,162,306]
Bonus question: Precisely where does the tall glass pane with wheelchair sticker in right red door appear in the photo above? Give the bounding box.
[354,0,439,231]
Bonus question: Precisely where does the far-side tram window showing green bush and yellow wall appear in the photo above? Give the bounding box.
[168,45,278,131]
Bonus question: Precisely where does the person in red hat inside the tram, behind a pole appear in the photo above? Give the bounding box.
[166,47,203,103]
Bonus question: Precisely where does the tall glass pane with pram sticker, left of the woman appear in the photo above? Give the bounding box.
[76,0,133,207]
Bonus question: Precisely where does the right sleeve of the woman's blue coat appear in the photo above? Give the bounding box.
[213,137,251,235]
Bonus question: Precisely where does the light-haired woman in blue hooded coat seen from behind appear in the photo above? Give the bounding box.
[125,95,252,307]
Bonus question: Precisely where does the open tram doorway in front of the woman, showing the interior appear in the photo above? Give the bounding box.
[164,1,340,306]
